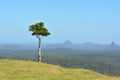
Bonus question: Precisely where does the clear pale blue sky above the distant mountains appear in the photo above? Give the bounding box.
[0,0,120,44]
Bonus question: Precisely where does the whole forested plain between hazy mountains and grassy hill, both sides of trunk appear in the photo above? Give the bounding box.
[0,49,120,76]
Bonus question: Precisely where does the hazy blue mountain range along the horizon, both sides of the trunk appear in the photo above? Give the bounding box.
[0,40,120,51]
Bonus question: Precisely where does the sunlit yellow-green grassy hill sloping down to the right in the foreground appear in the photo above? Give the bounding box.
[0,60,120,80]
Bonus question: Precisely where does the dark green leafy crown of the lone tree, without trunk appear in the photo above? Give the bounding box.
[29,22,50,36]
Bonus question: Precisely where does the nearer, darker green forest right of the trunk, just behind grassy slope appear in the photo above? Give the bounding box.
[43,54,120,76]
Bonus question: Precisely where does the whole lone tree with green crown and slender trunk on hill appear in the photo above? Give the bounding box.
[29,22,50,62]
